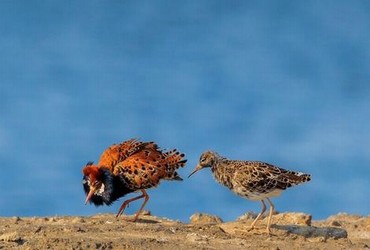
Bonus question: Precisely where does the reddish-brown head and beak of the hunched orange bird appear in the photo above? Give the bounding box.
[82,162,105,205]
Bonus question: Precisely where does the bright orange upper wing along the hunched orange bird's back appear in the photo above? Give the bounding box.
[98,139,158,172]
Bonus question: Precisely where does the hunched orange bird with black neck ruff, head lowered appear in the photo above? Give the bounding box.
[82,138,187,221]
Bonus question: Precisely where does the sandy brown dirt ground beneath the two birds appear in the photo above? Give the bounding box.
[0,213,370,250]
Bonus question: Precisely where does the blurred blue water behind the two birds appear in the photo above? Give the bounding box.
[0,0,370,221]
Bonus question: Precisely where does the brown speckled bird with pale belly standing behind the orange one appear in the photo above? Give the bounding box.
[188,151,311,234]
